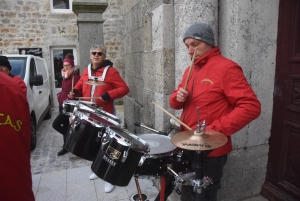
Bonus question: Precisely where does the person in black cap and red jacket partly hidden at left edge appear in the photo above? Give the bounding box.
[0,56,27,96]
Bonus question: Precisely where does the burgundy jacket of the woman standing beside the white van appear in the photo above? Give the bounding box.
[57,69,80,106]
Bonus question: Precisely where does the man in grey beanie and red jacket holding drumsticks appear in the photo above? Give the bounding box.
[170,23,261,201]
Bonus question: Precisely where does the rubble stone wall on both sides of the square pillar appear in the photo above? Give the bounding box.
[0,0,125,98]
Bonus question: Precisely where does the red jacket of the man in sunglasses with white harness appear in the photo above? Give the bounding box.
[74,60,129,114]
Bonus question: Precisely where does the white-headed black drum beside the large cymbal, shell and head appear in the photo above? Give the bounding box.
[134,134,176,179]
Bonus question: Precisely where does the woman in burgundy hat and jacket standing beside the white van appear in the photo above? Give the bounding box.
[52,53,80,156]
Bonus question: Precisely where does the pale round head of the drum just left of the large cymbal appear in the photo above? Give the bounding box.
[137,134,176,155]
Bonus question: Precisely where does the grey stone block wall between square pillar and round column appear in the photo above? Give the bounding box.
[123,1,174,133]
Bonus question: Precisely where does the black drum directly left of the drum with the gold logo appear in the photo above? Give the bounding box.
[65,111,106,161]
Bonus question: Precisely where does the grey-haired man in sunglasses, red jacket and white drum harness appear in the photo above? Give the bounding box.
[69,45,129,193]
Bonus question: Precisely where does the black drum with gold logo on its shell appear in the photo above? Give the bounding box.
[91,127,149,186]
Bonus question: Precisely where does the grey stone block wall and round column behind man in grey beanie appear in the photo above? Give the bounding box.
[123,0,279,200]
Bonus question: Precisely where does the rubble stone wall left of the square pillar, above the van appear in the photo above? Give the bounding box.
[0,0,78,76]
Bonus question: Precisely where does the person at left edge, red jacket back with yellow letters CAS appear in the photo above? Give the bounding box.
[0,72,34,201]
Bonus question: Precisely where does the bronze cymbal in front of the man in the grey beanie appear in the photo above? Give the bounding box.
[171,130,228,151]
